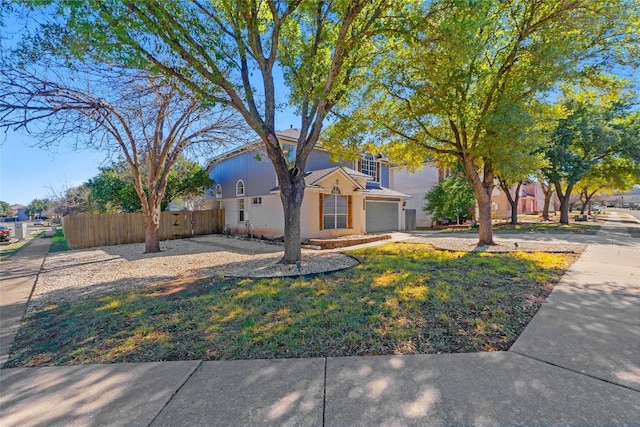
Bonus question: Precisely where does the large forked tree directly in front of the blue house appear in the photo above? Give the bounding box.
[26,0,404,263]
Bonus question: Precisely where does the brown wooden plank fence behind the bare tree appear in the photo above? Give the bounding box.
[62,209,224,249]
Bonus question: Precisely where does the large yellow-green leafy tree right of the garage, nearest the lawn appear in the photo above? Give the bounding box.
[334,0,639,244]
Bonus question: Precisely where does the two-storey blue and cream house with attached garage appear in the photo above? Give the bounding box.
[206,129,408,240]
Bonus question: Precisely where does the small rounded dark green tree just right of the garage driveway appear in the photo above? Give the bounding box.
[424,176,476,223]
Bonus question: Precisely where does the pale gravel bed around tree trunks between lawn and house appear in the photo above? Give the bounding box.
[27,233,586,311]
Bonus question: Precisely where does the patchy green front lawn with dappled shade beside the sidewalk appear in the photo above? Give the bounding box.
[1,243,578,367]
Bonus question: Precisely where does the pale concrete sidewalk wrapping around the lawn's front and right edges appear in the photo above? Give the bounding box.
[0,218,640,427]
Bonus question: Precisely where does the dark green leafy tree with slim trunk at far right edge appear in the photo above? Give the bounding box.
[543,90,640,224]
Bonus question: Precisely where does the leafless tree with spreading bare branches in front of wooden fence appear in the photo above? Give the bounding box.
[0,63,243,253]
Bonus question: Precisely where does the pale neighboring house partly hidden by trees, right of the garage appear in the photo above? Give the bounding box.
[391,162,444,228]
